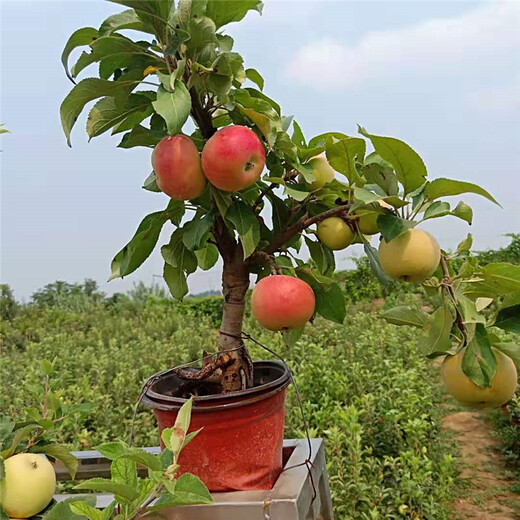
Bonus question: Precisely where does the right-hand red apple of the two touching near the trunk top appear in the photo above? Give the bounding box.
[202,125,265,191]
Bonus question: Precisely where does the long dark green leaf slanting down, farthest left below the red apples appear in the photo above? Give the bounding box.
[110,210,169,280]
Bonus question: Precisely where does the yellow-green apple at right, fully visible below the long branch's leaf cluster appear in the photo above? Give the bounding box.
[379,228,441,282]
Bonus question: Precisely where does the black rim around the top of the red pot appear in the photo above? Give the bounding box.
[142,360,291,412]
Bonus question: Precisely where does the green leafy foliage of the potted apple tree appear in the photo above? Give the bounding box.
[60,0,520,386]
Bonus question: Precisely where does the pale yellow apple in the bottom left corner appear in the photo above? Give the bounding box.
[0,453,56,518]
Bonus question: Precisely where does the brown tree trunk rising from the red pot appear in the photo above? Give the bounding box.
[219,247,253,393]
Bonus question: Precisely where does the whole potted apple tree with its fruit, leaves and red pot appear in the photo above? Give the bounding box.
[61,0,520,490]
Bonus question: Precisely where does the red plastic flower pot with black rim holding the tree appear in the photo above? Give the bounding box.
[143,361,290,491]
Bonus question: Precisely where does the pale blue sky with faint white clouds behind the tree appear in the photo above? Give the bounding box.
[0,0,520,300]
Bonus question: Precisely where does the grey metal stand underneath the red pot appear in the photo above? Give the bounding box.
[54,439,334,520]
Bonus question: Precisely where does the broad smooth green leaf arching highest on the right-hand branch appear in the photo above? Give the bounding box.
[359,127,428,194]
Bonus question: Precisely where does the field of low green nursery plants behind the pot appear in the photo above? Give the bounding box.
[0,237,519,519]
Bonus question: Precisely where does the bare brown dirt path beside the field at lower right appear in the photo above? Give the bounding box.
[443,412,520,520]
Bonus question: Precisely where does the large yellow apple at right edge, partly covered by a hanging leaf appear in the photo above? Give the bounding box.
[441,349,518,408]
